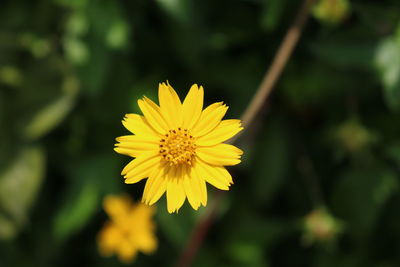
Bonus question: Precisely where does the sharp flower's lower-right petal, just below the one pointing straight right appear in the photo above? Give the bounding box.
[194,159,231,190]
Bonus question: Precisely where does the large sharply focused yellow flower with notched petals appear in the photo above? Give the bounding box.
[115,83,243,213]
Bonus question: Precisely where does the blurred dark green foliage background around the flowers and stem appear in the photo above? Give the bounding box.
[0,0,400,267]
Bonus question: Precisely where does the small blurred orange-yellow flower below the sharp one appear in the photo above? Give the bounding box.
[97,196,157,263]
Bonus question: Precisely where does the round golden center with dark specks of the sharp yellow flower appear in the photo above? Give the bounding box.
[160,127,196,165]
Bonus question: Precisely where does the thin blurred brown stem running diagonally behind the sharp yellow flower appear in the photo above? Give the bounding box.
[177,0,313,267]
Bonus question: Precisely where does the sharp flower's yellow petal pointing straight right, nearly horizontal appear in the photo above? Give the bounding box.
[196,144,243,166]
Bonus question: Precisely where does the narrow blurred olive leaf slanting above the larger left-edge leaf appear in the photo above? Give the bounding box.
[24,77,79,140]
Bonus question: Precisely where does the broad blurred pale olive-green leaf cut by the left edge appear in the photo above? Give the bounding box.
[0,147,45,239]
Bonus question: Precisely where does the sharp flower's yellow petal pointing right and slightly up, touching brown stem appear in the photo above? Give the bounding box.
[196,120,243,146]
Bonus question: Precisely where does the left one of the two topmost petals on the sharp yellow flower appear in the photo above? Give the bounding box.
[158,83,182,129]
